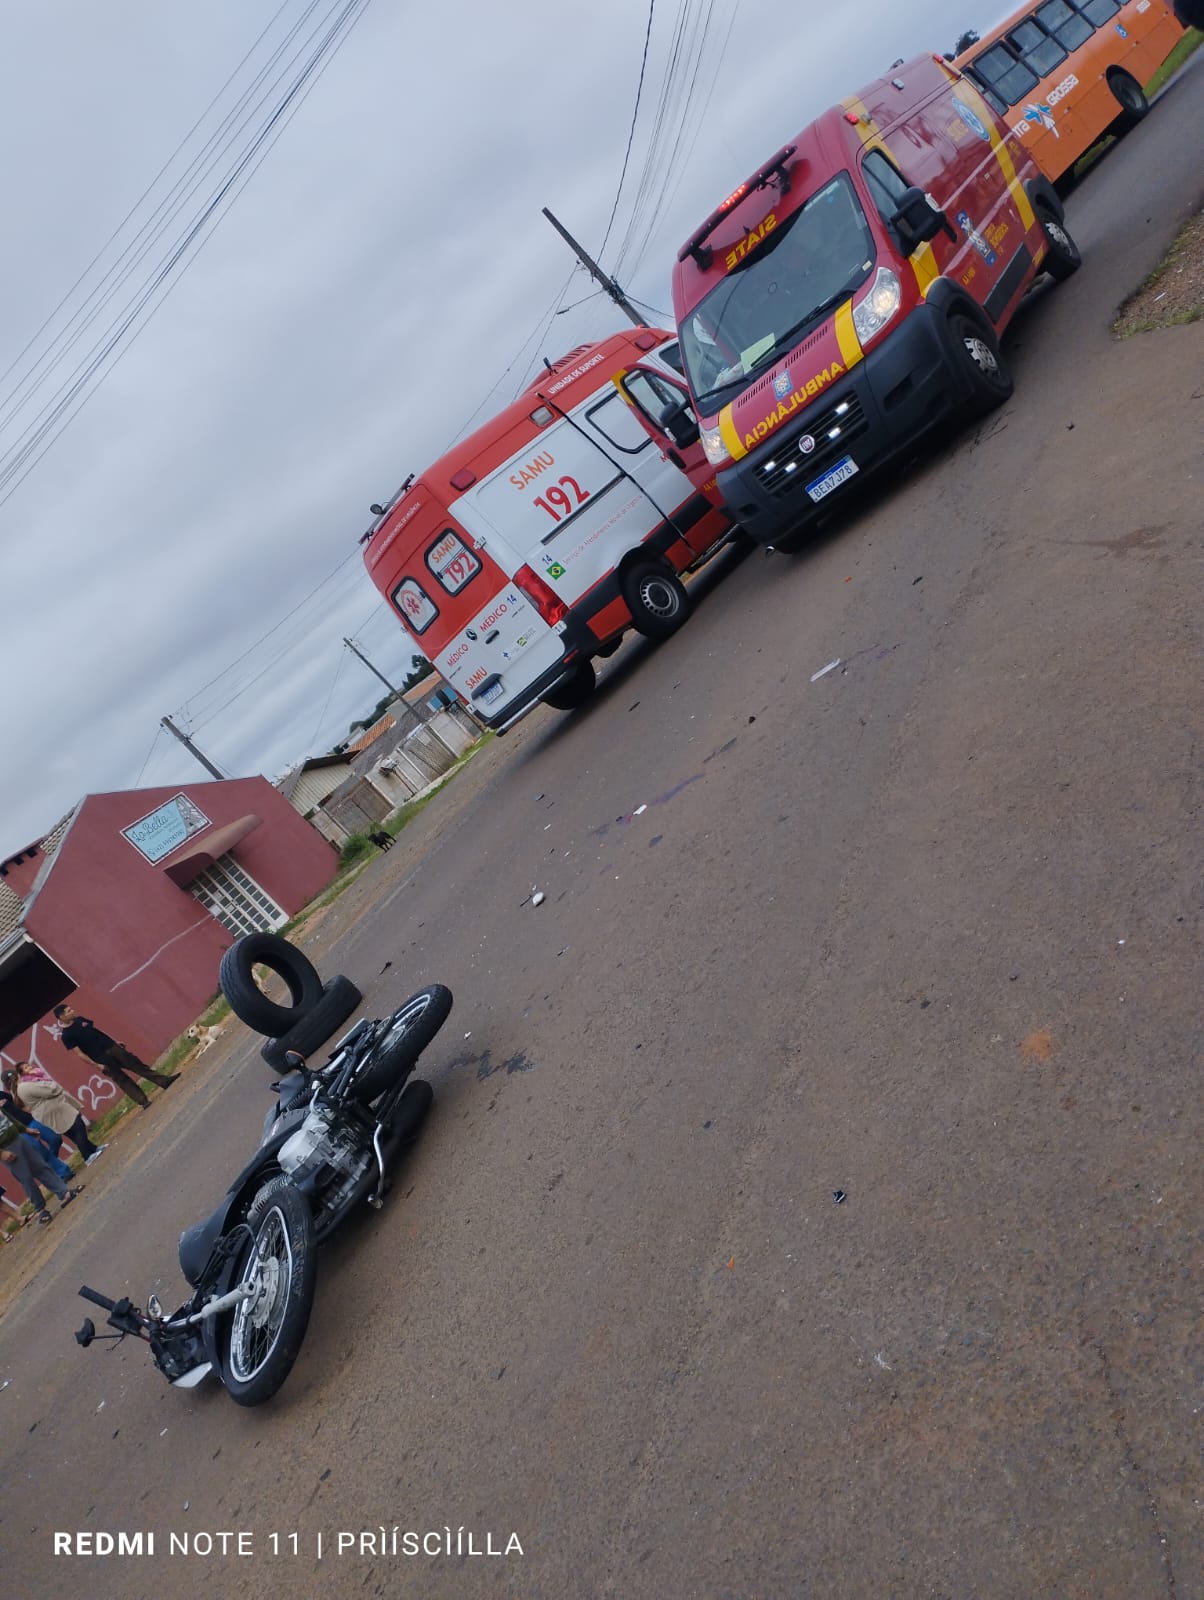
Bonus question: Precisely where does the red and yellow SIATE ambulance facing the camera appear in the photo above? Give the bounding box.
[640,56,1079,547]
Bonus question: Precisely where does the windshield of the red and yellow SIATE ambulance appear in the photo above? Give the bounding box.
[680,173,876,406]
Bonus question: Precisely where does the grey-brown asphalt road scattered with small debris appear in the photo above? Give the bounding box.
[0,61,1204,1600]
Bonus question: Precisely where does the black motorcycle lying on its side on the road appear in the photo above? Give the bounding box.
[75,984,452,1405]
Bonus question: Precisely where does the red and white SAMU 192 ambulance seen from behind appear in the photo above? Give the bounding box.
[362,328,732,730]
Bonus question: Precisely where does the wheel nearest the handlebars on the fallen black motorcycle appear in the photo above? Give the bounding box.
[223,1178,317,1405]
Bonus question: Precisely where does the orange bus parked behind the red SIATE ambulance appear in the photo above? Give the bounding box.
[954,0,1183,182]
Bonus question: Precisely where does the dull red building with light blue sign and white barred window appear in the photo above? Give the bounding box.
[0,778,338,1117]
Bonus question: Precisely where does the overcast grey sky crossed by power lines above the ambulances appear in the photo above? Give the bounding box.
[0,0,1010,854]
